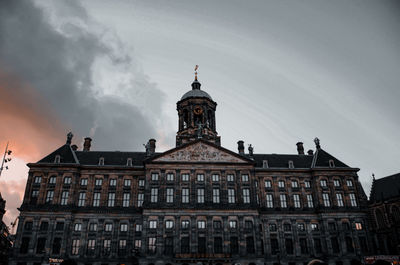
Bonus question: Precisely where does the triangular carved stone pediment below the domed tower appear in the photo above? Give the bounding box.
[152,141,251,163]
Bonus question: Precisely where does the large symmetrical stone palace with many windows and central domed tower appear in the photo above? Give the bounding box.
[11,74,371,265]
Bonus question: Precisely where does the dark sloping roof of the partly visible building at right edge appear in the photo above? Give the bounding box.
[370,173,400,202]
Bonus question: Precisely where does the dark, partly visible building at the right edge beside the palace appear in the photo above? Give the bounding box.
[369,173,400,255]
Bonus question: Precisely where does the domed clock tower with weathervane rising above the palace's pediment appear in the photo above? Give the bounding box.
[176,72,221,146]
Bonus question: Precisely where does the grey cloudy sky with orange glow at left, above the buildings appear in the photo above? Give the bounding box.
[0,0,400,227]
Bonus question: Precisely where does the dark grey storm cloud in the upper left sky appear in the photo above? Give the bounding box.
[0,0,163,150]
